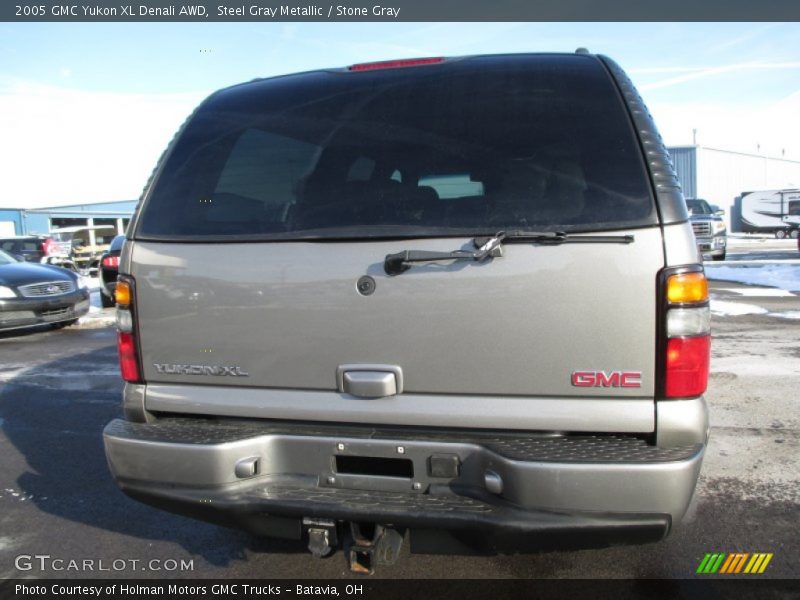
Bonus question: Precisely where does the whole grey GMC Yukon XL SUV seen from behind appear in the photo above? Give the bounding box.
[105,52,709,571]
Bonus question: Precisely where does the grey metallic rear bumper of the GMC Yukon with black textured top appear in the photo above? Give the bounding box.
[104,418,704,536]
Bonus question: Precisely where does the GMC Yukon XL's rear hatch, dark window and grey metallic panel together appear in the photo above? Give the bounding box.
[129,55,664,408]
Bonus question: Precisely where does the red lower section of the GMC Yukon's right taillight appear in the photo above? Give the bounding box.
[665,335,711,398]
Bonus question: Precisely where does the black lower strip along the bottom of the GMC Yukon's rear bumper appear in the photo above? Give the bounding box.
[122,482,671,550]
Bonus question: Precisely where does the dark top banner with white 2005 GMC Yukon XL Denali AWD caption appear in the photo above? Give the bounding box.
[0,0,800,22]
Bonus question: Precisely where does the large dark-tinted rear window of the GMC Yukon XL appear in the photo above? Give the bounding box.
[136,55,656,240]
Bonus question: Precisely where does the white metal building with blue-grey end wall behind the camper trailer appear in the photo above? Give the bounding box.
[667,146,800,231]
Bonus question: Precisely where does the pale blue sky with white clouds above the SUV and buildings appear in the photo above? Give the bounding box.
[0,23,800,208]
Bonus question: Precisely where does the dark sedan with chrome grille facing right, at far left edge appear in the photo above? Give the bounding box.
[0,250,89,331]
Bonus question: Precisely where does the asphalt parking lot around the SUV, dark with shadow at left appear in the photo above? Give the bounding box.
[0,252,800,579]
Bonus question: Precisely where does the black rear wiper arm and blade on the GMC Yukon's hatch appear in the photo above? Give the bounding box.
[383,231,633,275]
